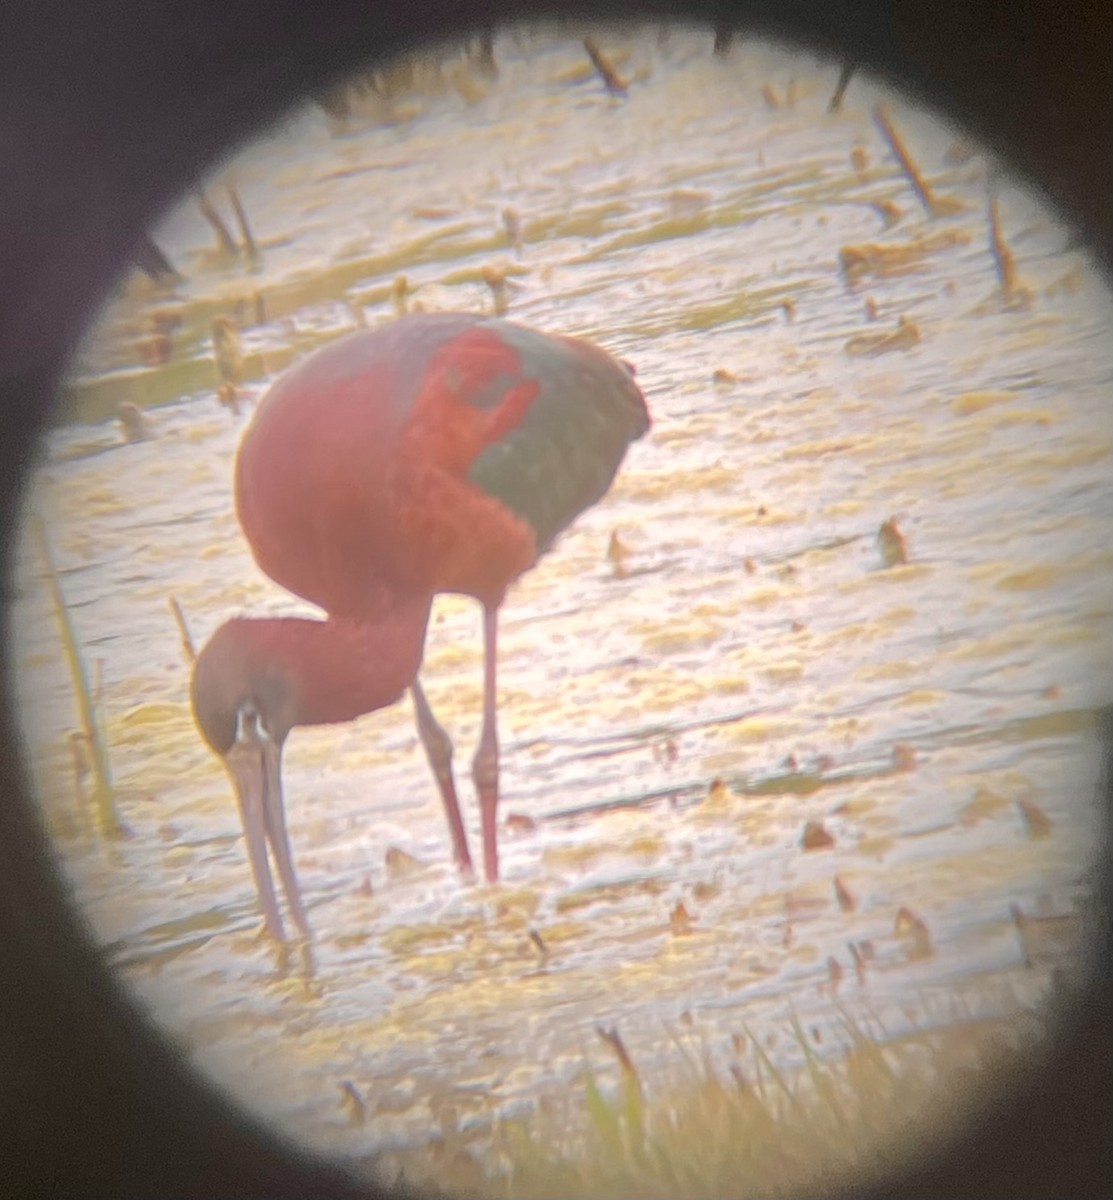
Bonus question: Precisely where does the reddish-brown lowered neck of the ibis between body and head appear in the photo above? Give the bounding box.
[260,596,432,725]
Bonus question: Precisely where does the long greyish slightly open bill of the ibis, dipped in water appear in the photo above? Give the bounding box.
[224,713,313,942]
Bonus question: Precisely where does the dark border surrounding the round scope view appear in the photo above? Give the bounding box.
[0,0,1113,1200]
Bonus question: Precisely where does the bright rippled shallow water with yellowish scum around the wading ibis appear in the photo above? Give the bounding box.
[8,32,1113,1180]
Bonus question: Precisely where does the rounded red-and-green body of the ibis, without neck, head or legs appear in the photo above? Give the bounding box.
[236,313,649,616]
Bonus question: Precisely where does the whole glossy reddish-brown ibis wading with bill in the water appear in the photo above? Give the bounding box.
[191,313,649,938]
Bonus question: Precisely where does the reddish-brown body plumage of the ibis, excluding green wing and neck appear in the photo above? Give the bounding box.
[236,318,539,609]
